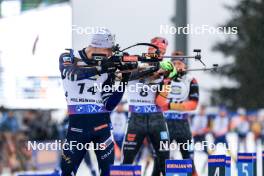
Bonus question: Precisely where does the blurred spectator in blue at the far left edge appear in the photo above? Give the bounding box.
[0,111,19,133]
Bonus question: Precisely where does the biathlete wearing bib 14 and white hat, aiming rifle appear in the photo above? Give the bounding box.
[60,30,127,176]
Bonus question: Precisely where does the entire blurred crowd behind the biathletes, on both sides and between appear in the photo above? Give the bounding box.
[0,103,264,173]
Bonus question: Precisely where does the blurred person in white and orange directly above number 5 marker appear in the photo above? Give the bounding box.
[231,108,250,152]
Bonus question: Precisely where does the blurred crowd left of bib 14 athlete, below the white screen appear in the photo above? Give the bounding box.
[0,107,61,173]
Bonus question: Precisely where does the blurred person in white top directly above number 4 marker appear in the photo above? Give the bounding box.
[212,107,229,148]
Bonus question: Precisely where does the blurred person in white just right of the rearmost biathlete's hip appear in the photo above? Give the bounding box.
[192,105,209,154]
